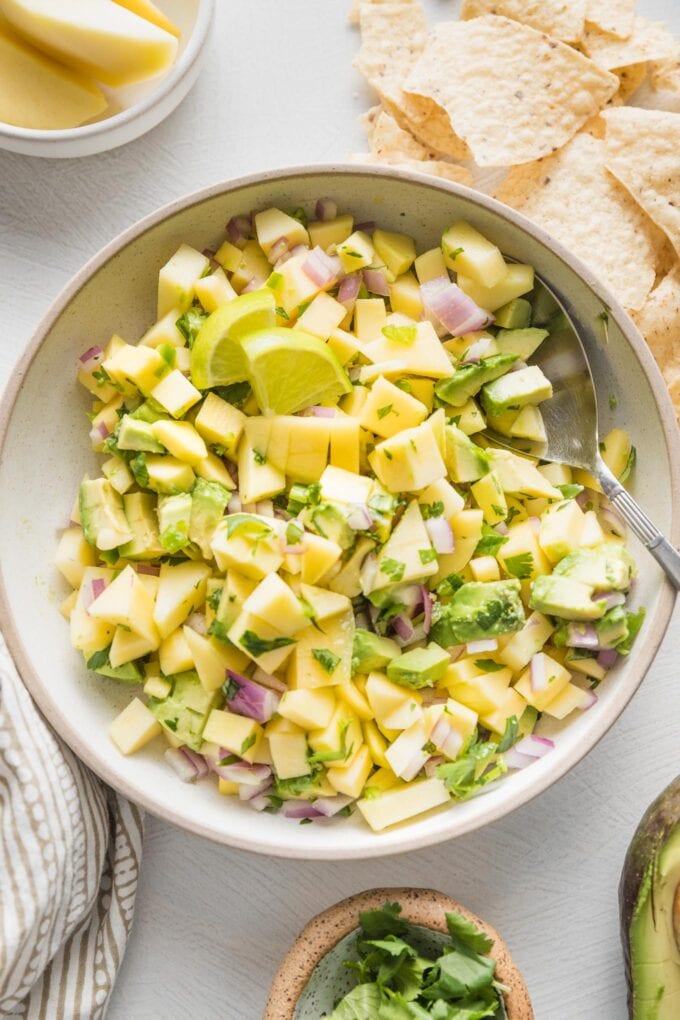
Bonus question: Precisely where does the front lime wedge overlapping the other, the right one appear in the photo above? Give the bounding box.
[241,327,352,414]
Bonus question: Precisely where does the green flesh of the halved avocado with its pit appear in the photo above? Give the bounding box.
[628,824,680,1020]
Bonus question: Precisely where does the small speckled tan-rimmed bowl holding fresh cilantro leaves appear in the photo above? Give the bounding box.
[262,888,533,1020]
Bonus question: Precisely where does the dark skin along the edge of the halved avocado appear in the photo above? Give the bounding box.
[619,776,680,1020]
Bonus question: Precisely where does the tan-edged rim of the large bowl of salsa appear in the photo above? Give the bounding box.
[0,161,680,860]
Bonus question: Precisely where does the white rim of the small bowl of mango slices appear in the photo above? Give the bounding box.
[0,0,215,145]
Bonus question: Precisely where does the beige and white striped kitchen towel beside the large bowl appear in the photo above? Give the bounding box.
[0,635,143,1020]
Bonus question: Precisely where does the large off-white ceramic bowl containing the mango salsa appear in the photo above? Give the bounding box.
[0,164,680,859]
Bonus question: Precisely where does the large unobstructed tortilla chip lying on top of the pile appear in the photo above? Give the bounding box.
[404,14,619,166]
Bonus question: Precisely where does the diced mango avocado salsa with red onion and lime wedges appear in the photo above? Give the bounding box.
[56,199,643,830]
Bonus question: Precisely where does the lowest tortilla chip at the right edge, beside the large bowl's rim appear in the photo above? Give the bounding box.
[633,265,680,416]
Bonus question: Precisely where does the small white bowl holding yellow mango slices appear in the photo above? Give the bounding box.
[0,0,215,159]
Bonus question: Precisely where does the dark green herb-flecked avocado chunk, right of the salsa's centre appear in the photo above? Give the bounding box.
[430,579,525,648]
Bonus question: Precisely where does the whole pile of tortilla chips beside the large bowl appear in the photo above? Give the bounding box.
[351,0,680,416]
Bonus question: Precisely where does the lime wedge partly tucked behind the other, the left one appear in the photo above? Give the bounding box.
[191,290,276,390]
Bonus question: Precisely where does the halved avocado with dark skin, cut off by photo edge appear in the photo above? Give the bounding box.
[619,776,680,1020]
